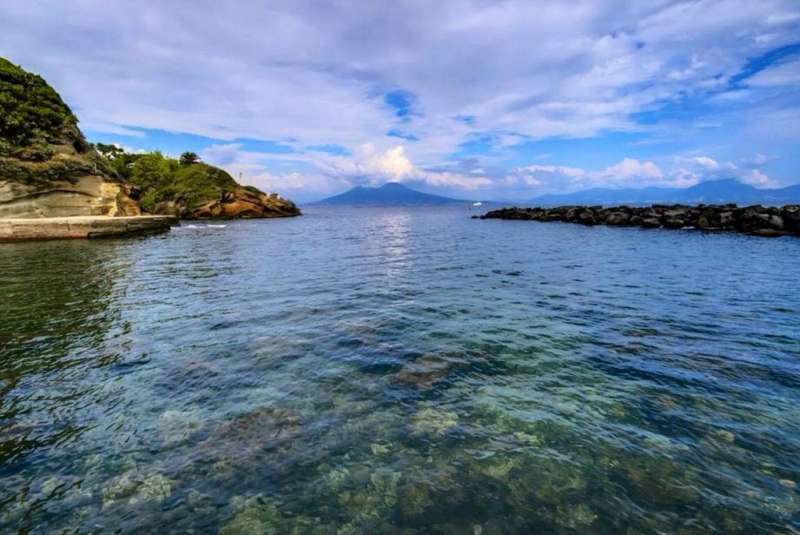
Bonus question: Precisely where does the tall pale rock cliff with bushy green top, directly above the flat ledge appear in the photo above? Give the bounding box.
[0,58,140,218]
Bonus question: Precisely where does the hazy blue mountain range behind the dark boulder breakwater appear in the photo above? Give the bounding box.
[529,179,800,206]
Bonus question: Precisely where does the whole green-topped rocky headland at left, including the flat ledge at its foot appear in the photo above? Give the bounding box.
[0,58,300,240]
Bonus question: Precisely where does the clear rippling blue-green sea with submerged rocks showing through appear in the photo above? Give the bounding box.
[0,208,800,534]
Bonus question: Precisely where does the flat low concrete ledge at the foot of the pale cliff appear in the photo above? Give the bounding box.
[0,215,179,241]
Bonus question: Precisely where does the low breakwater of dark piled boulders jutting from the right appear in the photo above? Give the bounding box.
[482,204,800,237]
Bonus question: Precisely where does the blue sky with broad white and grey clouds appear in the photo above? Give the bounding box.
[0,0,800,202]
